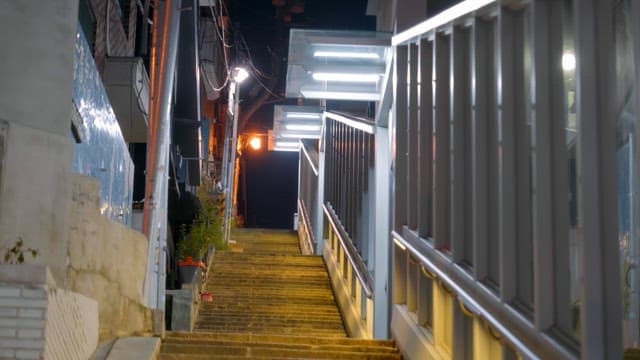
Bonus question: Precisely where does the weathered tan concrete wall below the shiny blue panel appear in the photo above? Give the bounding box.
[68,175,153,341]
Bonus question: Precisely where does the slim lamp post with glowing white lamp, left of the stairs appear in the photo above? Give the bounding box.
[222,67,249,243]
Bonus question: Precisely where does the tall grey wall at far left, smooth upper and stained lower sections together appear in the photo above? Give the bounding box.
[0,0,78,285]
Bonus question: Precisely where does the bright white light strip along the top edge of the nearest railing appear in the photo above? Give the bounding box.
[391,0,500,46]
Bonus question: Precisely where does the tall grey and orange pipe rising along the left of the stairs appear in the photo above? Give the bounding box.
[143,0,181,334]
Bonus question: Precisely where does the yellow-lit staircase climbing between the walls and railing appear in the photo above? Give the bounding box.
[160,229,401,360]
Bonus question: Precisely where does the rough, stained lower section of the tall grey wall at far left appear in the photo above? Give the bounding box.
[0,121,73,287]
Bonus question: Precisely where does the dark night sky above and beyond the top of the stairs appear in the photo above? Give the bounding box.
[230,0,375,229]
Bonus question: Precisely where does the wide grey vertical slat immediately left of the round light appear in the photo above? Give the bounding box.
[531,0,569,330]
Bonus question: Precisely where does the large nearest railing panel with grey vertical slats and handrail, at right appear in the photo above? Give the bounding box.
[392,0,622,358]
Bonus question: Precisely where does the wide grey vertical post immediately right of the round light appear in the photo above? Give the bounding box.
[573,0,620,359]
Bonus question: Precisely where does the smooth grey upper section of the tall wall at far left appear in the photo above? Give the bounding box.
[0,0,78,137]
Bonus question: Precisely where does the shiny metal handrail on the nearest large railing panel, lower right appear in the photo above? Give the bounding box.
[391,231,573,359]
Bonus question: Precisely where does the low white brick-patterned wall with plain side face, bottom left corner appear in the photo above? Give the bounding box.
[0,265,98,360]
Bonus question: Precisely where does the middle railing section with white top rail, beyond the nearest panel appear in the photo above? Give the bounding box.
[321,112,376,338]
